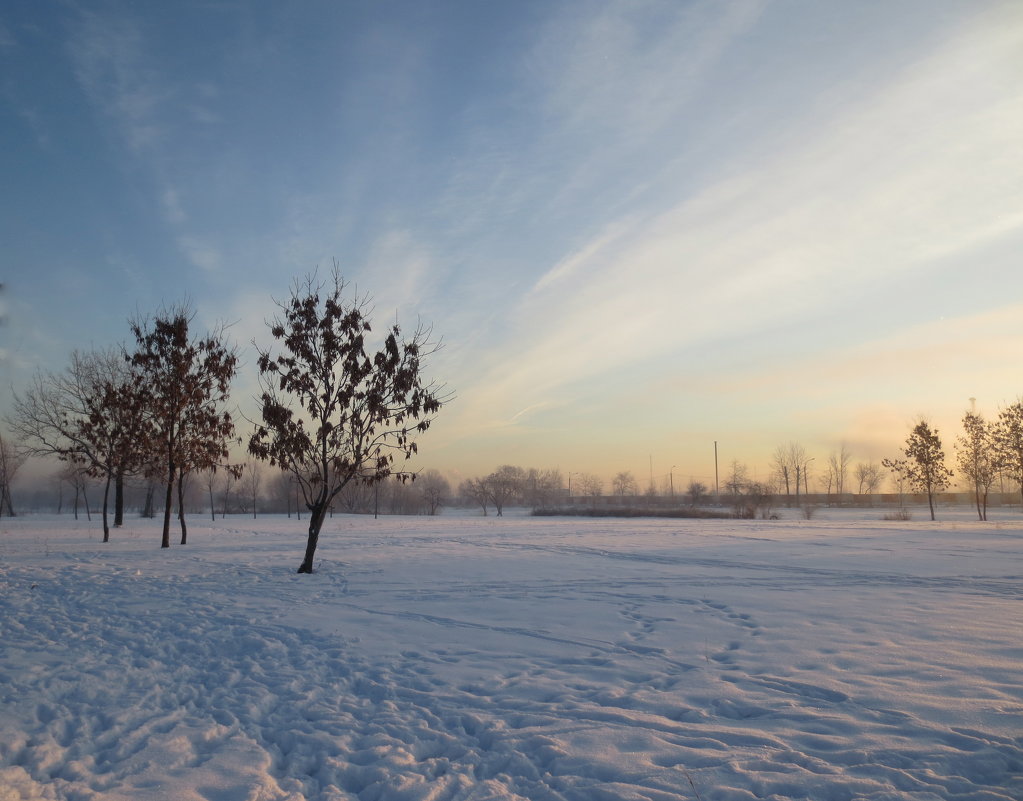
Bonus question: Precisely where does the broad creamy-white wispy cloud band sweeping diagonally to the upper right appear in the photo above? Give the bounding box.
[437,7,1023,458]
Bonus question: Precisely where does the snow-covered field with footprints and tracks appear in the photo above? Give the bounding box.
[0,511,1023,801]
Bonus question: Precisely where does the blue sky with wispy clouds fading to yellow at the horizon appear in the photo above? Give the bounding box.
[0,0,1023,488]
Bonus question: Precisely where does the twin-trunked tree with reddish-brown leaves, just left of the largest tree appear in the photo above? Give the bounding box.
[131,305,238,548]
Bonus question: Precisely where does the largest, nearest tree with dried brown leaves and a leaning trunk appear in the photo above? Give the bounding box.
[249,272,446,573]
